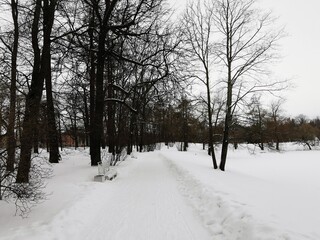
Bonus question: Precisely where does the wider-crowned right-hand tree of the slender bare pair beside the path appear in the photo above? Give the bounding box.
[213,0,283,171]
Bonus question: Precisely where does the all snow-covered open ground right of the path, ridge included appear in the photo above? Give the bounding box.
[162,144,320,239]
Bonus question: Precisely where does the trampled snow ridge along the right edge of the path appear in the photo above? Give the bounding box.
[163,153,291,240]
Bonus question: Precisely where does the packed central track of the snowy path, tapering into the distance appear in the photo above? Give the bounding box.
[81,153,210,240]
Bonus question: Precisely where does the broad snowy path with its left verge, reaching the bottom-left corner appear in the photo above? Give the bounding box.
[0,153,211,240]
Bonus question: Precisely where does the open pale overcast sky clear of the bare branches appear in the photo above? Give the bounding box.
[172,0,320,118]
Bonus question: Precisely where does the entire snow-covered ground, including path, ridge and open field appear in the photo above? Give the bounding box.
[0,145,320,240]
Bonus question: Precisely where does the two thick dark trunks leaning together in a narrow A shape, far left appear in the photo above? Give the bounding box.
[16,0,60,183]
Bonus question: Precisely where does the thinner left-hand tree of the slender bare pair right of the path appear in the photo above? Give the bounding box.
[182,0,218,169]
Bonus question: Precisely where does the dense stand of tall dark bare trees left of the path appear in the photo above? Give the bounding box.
[0,0,184,214]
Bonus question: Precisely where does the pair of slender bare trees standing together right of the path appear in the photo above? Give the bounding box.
[179,0,285,171]
